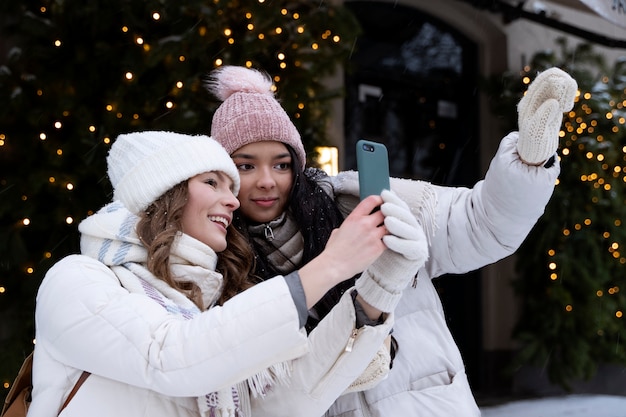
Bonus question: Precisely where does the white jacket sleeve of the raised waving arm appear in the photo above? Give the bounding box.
[416,132,560,277]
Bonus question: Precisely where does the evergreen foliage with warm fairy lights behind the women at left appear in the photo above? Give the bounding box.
[0,0,359,397]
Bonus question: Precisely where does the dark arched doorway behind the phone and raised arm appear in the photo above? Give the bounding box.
[345,1,482,388]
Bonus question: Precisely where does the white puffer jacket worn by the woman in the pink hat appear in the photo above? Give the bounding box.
[326,132,560,417]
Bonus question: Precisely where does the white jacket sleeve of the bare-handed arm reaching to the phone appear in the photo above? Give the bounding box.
[35,255,308,396]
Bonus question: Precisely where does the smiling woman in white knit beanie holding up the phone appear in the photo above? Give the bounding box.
[28,131,424,417]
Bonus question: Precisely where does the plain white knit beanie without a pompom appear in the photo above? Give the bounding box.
[107,131,239,214]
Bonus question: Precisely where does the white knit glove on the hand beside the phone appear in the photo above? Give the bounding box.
[356,190,428,313]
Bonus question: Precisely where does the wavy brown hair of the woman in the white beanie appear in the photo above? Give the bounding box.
[137,181,255,308]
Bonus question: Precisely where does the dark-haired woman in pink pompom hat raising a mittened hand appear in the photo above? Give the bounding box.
[208,66,577,417]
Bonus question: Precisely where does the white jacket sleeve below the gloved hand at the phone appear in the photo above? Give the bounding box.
[247,291,394,417]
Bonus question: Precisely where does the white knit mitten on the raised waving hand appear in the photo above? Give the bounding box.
[517,68,578,165]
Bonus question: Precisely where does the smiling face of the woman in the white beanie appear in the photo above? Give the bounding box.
[182,171,239,252]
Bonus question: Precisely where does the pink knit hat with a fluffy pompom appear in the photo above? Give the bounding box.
[206,65,306,169]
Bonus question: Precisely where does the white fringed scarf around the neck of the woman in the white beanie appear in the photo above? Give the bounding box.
[78,202,290,417]
